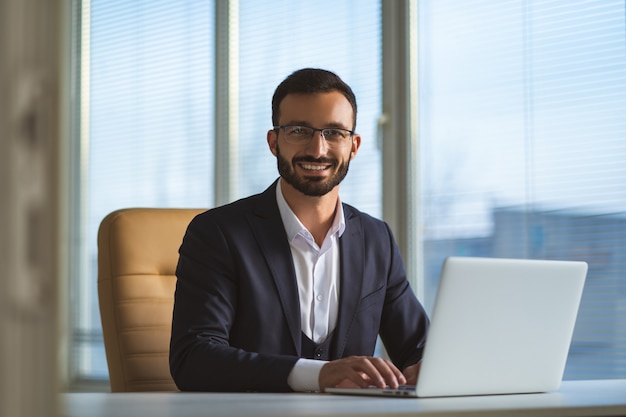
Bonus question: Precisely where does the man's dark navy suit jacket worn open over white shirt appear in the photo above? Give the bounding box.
[170,183,428,391]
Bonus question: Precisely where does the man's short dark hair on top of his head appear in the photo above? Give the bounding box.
[272,68,356,129]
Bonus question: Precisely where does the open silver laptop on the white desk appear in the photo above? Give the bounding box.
[326,257,587,397]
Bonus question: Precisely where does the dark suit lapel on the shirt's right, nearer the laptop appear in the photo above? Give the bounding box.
[334,205,365,357]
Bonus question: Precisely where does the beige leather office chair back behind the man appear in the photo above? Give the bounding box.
[98,208,204,392]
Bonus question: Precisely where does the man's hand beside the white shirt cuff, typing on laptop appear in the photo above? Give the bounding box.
[319,356,406,392]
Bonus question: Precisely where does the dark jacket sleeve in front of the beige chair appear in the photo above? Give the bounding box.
[170,215,298,392]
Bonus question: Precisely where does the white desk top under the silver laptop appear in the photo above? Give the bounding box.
[61,380,626,417]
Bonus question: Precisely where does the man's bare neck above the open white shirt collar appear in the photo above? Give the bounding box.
[280,178,339,246]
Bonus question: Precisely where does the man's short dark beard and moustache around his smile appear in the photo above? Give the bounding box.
[276,144,350,197]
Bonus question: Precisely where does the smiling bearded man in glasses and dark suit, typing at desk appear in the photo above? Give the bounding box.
[170,69,428,391]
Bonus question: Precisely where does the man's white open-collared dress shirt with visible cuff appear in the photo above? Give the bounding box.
[276,181,346,391]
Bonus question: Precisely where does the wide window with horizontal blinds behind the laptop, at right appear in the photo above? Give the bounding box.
[419,0,626,379]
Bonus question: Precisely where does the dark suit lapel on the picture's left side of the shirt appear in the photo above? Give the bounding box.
[249,183,302,355]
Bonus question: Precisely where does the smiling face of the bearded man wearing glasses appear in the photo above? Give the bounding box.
[268,91,361,197]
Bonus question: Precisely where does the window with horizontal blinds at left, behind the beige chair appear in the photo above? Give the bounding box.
[73,0,214,378]
